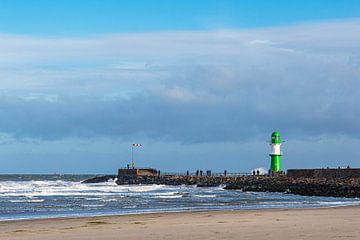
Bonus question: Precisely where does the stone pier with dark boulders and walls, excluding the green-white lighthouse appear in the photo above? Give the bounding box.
[84,169,360,198]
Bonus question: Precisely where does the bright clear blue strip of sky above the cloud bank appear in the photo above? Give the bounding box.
[0,0,360,36]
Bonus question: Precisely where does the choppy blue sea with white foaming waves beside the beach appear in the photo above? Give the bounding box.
[0,174,360,221]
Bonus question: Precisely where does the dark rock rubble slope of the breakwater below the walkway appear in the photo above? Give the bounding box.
[84,175,360,198]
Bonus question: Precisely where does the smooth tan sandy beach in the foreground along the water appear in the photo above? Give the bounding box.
[0,206,360,240]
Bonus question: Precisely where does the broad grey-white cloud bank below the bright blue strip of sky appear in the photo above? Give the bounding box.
[0,20,360,144]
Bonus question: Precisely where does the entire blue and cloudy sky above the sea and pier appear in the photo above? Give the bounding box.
[0,0,360,173]
